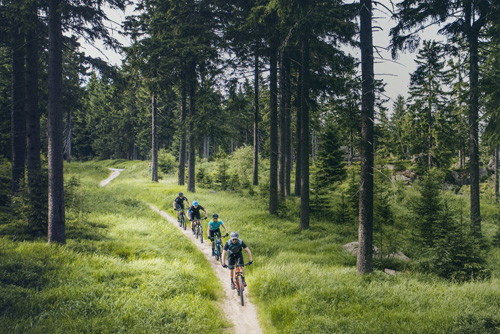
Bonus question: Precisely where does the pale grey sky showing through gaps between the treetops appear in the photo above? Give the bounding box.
[80,0,443,111]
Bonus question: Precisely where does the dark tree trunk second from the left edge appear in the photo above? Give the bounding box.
[26,7,43,230]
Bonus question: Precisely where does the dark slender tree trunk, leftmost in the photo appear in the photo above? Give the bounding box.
[11,21,26,194]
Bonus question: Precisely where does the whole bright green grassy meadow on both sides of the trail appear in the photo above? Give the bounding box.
[0,161,500,334]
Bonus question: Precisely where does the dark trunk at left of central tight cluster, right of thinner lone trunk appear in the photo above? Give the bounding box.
[269,46,278,214]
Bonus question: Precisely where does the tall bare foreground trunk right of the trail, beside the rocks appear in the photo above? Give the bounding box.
[357,0,375,274]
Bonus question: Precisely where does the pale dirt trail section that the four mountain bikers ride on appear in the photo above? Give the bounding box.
[149,204,262,334]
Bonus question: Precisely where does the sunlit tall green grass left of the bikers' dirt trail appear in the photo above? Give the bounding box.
[0,163,229,333]
